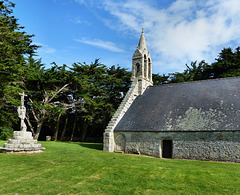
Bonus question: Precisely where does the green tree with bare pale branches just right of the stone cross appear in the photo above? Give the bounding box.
[23,61,70,139]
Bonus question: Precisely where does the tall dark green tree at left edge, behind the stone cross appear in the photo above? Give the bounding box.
[0,0,37,131]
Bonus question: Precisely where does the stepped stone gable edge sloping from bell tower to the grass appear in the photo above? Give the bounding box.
[103,79,138,152]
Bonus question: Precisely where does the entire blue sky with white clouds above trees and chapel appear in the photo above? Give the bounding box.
[12,0,240,74]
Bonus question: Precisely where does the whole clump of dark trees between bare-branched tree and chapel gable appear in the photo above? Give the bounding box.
[70,59,131,141]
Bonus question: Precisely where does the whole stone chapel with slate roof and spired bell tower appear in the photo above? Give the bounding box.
[103,31,240,163]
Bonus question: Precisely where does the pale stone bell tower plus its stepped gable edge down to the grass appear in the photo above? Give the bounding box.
[103,29,153,152]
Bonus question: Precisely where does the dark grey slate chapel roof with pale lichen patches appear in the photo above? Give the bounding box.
[115,77,240,131]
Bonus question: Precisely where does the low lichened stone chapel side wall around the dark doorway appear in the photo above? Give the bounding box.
[114,131,240,163]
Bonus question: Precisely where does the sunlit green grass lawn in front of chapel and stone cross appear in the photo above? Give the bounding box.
[0,141,240,195]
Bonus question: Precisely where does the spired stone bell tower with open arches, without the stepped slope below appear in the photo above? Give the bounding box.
[132,29,153,95]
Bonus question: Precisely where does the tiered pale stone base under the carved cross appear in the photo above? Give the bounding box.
[0,131,45,154]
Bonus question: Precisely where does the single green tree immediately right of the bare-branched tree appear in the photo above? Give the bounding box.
[71,60,109,141]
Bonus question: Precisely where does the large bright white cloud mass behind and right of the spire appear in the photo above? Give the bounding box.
[100,0,240,73]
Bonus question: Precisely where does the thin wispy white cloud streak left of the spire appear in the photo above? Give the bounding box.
[75,38,124,53]
